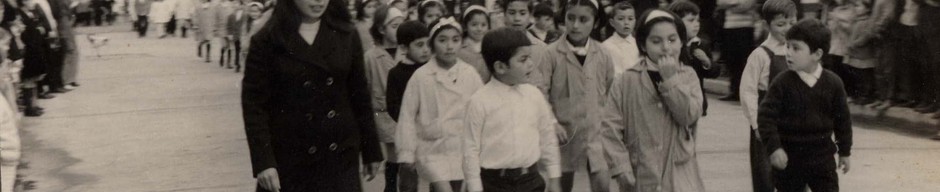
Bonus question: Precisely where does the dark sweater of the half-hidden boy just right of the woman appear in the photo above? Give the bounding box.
[385,62,427,122]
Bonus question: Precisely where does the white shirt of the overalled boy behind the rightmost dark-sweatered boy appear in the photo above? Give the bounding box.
[738,36,787,129]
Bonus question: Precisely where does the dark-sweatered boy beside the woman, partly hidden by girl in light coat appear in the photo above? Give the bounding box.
[385,21,431,192]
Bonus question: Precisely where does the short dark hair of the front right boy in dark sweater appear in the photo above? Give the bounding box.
[787,18,831,53]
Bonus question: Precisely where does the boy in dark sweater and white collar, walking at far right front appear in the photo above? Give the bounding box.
[757,19,852,192]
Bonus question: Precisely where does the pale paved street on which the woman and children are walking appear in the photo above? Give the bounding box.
[12,27,940,192]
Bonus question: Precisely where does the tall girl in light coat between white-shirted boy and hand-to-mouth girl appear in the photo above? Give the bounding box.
[536,0,614,191]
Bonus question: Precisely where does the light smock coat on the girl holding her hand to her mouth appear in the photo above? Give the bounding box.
[604,59,705,192]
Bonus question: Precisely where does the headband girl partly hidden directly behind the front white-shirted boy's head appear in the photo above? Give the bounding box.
[457,5,490,83]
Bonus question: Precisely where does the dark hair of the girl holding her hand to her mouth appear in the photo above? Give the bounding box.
[634,9,689,58]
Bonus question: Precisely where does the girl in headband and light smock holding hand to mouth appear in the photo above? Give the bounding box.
[603,9,705,191]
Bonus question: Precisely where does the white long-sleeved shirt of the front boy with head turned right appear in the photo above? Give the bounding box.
[463,78,561,191]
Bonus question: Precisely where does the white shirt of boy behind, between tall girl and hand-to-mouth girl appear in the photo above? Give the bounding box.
[601,34,640,76]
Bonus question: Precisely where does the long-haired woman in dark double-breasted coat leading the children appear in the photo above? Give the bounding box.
[242,0,382,192]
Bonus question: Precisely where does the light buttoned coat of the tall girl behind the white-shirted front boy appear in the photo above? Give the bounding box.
[536,37,614,173]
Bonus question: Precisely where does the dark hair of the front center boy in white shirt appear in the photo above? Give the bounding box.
[480,27,532,73]
